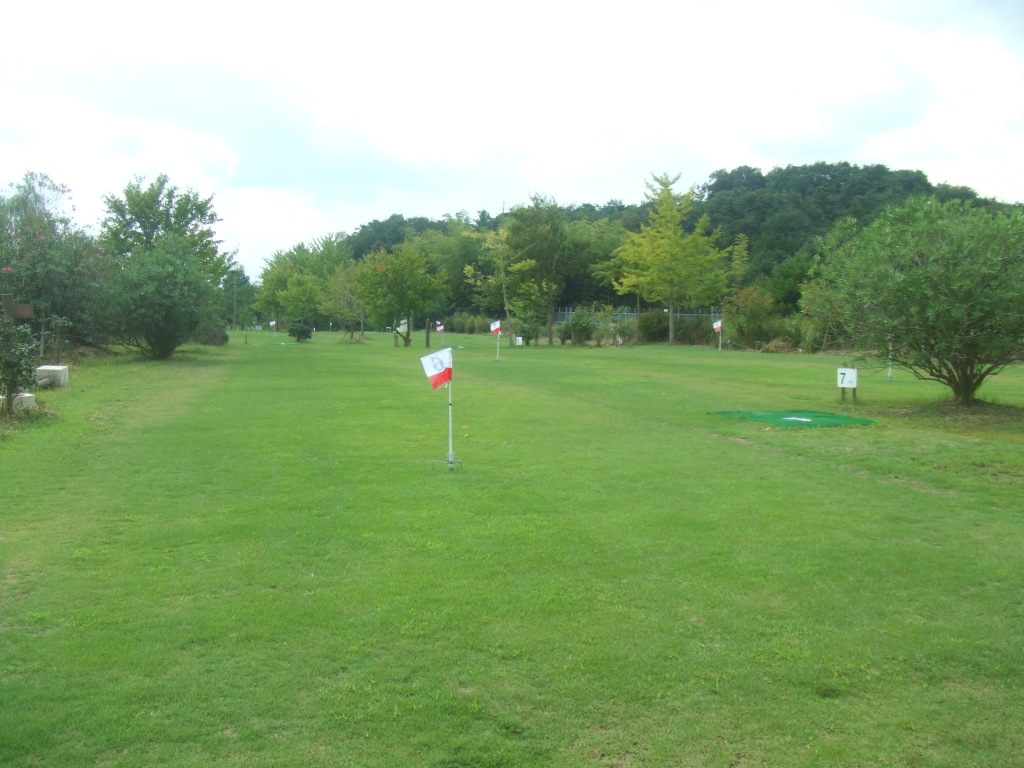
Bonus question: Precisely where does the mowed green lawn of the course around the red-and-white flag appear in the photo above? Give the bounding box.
[6,333,1024,768]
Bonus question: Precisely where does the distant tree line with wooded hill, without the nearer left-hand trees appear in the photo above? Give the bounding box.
[251,163,1013,348]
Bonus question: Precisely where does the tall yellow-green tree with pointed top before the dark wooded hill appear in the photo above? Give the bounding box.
[607,174,746,343]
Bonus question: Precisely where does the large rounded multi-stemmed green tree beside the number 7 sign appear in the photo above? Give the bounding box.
[803,197,1024,406]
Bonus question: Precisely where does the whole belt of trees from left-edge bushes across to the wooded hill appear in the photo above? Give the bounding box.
[0,163,1020,405]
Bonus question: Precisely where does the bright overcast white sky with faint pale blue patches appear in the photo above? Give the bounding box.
[0,0,1024,281]
